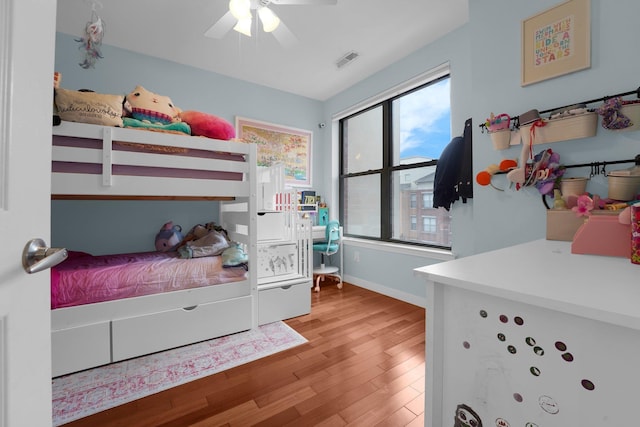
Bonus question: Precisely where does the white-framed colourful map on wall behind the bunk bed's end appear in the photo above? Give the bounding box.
[236,117,313,187]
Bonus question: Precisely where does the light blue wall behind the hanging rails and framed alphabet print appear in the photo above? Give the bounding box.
[469,0,640,252]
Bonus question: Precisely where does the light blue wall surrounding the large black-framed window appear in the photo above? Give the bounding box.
[321,26,474,305]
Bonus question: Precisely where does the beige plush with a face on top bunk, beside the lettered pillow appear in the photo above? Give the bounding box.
[124,86,180,125]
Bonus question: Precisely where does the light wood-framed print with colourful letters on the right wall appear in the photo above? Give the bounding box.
[521,0,591,86]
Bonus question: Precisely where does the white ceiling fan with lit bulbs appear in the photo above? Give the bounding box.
[204,0,338,46]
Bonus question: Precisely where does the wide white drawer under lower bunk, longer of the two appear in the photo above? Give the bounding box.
[111,296,252,362]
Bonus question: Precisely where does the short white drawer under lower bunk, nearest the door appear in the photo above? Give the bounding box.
[51,322,111,377]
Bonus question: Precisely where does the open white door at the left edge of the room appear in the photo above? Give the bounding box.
[0,0,56,427]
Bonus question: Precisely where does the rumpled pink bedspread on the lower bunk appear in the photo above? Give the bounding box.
[51,252,246,309]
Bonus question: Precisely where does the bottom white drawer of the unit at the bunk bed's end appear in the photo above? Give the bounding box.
[258,279,312,325]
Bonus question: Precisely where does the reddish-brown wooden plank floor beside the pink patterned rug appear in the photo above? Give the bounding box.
[66,281,425,427]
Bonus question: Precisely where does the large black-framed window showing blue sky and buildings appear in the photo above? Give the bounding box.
[340,68,451,248]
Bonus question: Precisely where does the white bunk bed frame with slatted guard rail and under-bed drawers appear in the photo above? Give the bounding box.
[51,122,258,377]
